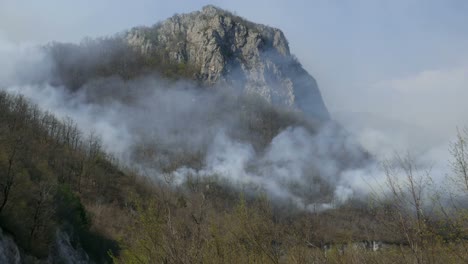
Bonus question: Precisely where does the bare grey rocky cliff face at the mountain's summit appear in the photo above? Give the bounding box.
[125,6,329,120]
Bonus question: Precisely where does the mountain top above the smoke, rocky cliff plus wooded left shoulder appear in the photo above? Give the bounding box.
[51,6,329,120]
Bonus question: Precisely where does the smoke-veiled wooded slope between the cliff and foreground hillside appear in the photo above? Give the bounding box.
[0,34,370,208]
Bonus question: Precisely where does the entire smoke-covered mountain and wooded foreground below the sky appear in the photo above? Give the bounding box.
[0,6,468,264]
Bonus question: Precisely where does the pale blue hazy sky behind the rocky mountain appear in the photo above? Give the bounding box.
[0,0,468,140]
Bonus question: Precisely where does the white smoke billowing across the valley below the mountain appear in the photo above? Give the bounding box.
[0,31,460,210]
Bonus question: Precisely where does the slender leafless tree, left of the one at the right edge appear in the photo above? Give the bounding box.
[379,154,435,263]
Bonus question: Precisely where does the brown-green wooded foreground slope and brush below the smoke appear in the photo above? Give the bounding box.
[0,89,468,263]
